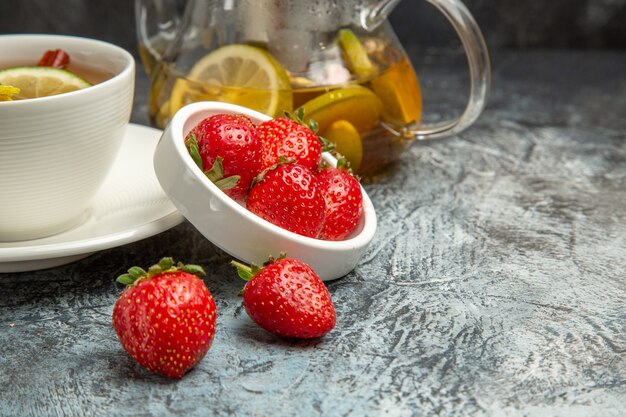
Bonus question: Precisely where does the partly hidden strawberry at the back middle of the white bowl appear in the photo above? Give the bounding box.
[258,118,322,171]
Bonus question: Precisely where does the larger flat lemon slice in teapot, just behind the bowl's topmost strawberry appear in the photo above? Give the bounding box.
[302,85,383,135]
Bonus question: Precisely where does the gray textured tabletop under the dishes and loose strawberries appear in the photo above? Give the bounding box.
[0,52,626,417]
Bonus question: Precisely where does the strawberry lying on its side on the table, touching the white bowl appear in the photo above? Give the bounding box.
[232,254,337,339]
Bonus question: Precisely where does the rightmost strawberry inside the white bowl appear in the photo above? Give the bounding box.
[316,164,363,240]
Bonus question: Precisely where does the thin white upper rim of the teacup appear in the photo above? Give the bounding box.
[0,33,135,108]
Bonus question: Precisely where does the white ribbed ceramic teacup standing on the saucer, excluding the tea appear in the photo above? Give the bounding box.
[0,35,135,241]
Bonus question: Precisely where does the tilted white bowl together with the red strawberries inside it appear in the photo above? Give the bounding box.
[154,102,376,280]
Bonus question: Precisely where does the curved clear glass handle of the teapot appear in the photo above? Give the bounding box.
[385,0,491,140]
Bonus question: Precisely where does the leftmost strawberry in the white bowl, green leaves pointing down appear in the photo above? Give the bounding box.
[185,114,261,200]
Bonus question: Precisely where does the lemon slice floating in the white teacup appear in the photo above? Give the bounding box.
[0,67,91,99]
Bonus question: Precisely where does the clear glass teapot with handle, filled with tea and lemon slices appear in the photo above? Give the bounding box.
[135,0,491,174]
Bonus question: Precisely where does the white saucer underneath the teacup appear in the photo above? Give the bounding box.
[0,123,185,273]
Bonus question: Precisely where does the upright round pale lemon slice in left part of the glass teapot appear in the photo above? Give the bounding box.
[170,44,293,117]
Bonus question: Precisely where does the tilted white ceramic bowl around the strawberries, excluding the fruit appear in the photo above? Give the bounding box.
[154,102,376,280]
